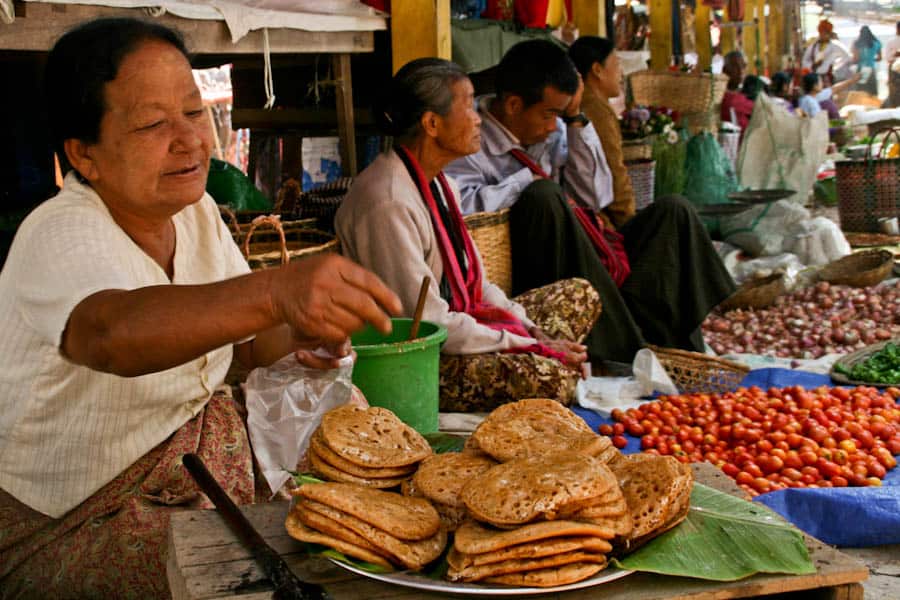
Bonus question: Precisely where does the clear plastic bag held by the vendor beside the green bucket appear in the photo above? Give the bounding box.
[245,353,353,493]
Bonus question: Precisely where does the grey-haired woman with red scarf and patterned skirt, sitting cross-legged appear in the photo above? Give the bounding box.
[335,58,600,412]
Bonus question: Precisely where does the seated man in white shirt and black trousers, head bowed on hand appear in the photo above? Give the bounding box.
[444,40,734,363]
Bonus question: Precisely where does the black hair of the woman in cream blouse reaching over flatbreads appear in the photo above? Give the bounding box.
[44,18,190,164]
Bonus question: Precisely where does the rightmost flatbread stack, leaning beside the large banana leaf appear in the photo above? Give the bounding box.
[611,454,694,552]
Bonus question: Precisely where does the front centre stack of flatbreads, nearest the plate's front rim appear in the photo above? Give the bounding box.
[447,449,631,587]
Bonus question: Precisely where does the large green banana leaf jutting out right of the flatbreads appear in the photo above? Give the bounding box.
[612,483,816,581]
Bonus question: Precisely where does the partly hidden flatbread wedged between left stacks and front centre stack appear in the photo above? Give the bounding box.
[412,452,497,507]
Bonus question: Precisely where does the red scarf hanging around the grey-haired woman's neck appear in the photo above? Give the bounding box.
[397,146,565,362]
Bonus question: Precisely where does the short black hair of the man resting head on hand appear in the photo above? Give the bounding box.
[495,40,578,108]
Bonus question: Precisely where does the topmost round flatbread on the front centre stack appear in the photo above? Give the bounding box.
[461,452,616,527]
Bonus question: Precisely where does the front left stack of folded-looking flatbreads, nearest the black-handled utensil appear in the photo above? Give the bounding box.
[285,483,447,570]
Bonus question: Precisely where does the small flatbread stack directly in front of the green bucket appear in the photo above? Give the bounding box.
[308,405,432,489]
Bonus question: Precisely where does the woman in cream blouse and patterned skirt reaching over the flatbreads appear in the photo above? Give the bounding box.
[0,19,400,598]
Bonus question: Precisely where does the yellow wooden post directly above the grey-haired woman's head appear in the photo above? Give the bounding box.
[391,0,451,73]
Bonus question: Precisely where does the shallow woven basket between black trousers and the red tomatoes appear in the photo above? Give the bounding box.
[647,344,750,394]
